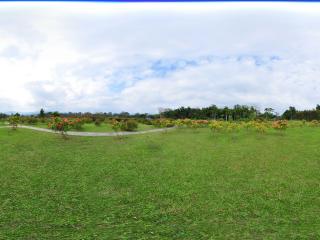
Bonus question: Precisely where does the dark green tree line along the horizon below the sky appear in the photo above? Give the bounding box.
[0,104,320,121]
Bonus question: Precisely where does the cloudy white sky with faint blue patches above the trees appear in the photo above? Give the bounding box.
[0,2,320,113]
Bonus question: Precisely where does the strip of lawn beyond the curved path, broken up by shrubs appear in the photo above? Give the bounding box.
[25,122,155,132]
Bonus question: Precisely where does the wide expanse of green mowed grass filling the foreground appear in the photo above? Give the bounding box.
[0,128,320,239]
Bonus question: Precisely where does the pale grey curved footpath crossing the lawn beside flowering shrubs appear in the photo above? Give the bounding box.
[0,125,175,137]
